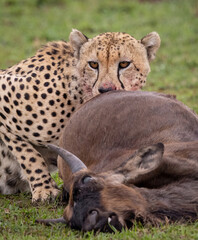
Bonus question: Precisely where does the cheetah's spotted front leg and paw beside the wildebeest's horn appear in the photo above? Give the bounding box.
[1,133,59,202]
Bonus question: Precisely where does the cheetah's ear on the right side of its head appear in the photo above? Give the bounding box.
[141,32,161,62]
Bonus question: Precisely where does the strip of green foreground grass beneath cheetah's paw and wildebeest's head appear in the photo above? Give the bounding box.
[0,189,198,240]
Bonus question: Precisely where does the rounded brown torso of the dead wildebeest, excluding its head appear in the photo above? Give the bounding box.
[58,91,198,191]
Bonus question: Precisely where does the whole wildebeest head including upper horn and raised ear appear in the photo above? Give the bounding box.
[36,143,164,232]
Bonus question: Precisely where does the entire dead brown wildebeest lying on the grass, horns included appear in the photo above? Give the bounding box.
[36,91,198,232]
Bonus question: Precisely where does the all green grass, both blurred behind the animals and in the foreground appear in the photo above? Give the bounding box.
[0,0,198,240]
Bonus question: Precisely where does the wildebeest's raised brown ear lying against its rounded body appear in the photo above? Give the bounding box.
[122,143,164,184]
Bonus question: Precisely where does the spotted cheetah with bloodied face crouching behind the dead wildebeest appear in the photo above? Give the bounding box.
[0,29,160,202]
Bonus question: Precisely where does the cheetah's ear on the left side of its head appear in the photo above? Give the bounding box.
[69,29,88,58]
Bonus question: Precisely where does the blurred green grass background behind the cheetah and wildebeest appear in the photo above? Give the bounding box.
[0,0,198,112]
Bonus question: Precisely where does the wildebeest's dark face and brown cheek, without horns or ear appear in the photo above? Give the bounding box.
[64,171,144,232]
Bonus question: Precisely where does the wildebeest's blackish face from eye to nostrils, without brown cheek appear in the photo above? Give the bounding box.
[64,171,122,232]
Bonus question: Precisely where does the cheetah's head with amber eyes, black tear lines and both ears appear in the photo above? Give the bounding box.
[70,30,160,97]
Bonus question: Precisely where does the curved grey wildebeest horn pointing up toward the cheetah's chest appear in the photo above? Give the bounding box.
[47,144,87,173]
